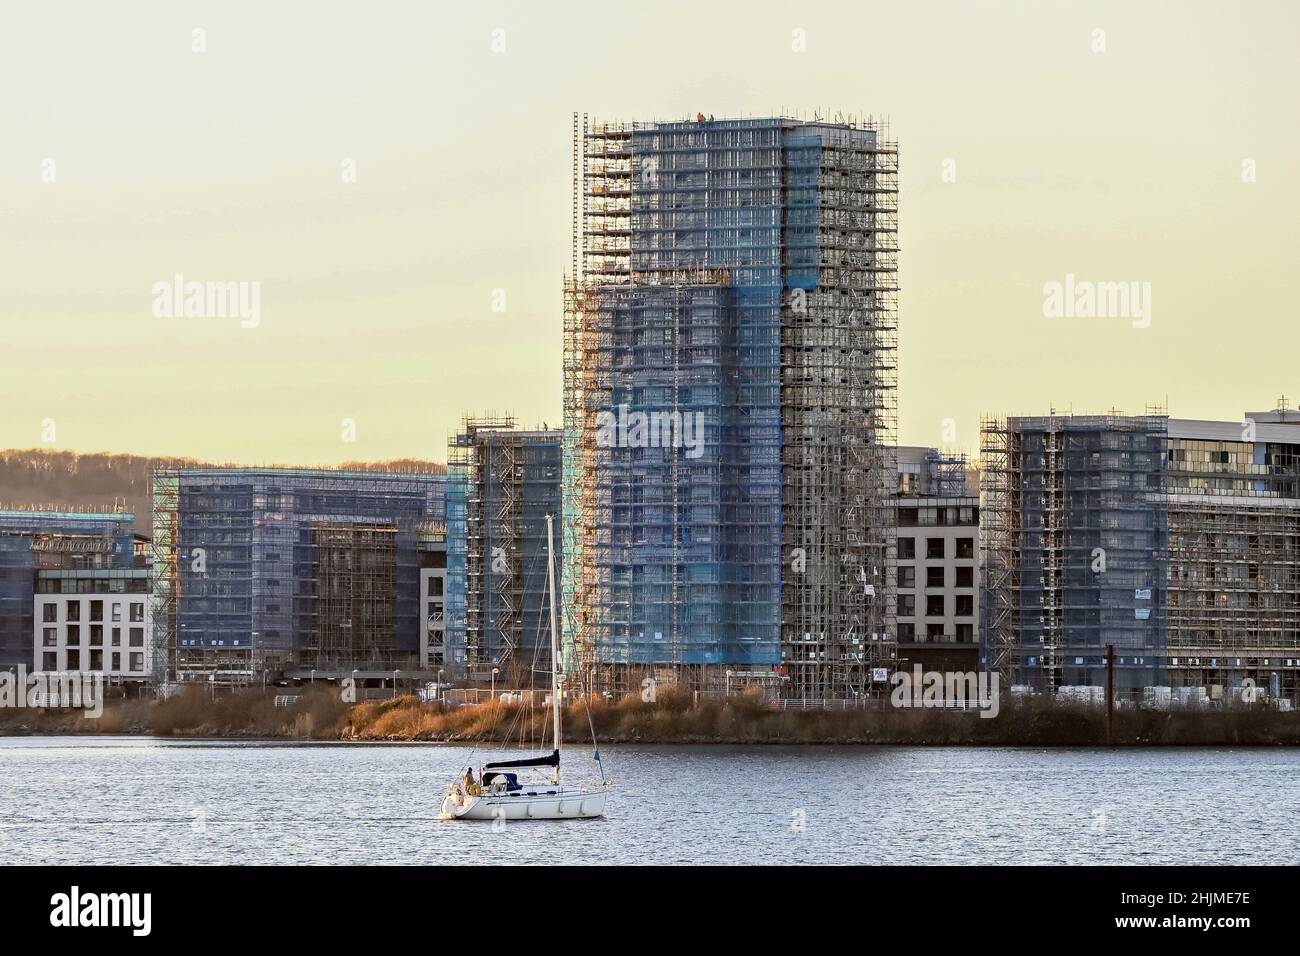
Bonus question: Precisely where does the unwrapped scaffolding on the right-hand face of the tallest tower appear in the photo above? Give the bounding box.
[781,124,898,698]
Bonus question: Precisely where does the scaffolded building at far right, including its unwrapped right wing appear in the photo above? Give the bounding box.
[980,408,1300,702]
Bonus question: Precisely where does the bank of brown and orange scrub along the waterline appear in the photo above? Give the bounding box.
[0,688,1300,747]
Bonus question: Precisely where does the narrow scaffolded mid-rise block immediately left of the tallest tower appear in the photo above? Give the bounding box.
[447,416,563,687]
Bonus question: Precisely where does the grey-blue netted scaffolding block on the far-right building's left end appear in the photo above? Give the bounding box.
[980,414,1169,692]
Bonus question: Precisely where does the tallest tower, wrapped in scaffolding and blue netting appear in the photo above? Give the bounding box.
[564,114,898,700]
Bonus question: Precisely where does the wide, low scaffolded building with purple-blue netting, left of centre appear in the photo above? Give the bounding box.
[151,468,447,685]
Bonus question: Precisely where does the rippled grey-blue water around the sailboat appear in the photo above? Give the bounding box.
[0,737,1300,864]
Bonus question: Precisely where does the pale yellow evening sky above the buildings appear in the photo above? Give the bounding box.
[0,0,1300,464]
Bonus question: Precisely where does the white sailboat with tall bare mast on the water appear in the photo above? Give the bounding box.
[441,515,610,821]
